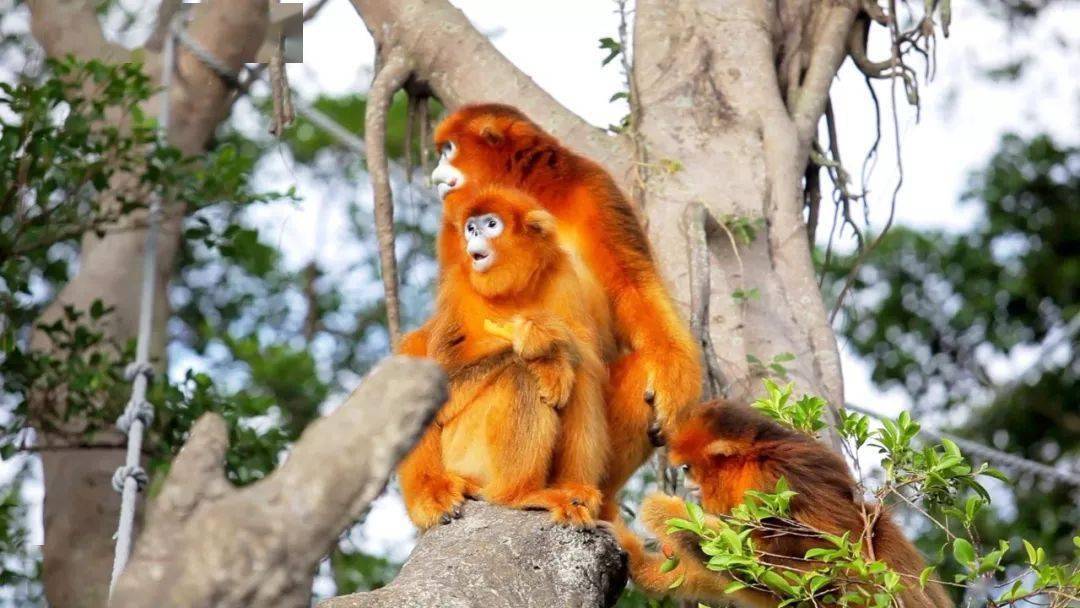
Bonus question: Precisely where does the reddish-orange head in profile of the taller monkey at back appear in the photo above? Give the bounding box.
[431,104,565,198]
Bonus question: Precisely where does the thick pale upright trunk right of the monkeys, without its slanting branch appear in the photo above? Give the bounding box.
[633,0,854,404]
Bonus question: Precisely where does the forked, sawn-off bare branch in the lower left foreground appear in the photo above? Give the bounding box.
[112,357,446,608]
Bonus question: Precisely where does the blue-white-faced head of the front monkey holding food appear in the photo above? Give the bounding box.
[440,186,564,297]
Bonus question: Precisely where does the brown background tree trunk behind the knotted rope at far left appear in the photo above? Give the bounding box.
[29,0,268,608]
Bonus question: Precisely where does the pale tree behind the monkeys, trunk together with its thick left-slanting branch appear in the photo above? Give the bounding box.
[352,0,855,404]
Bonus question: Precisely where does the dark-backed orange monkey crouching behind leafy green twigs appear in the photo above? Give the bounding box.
[615,401,953,608]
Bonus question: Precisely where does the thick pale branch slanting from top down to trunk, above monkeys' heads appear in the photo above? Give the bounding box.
[352,0,632,178]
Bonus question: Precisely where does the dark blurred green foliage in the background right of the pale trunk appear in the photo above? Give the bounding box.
[825,135,1080,564]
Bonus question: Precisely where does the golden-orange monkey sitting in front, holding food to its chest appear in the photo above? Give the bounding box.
[399,186,613,528]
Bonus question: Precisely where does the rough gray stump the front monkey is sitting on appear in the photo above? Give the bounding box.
[319,501,626,608]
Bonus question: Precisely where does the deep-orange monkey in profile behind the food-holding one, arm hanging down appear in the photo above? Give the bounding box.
[432,104,701,521]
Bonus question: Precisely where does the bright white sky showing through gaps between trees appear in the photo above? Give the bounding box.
[2,0,1080,591]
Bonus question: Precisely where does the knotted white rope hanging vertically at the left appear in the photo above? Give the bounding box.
[109,15,179,596]
